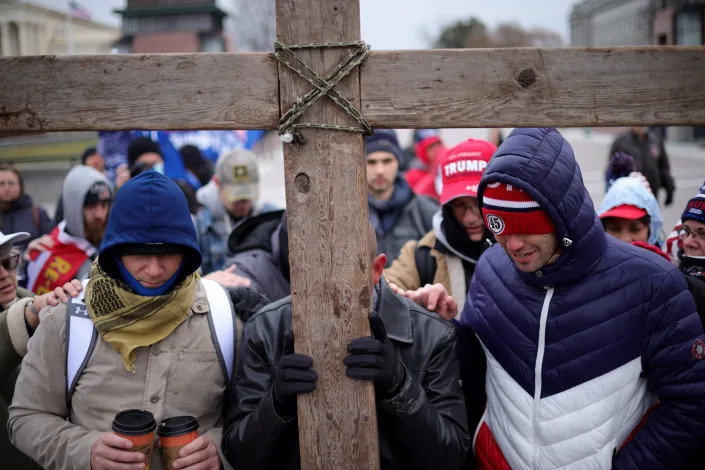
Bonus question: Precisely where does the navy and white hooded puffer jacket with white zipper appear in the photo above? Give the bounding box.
[461,129,705,470]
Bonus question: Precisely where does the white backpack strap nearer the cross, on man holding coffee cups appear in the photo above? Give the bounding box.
[201,279,236,385]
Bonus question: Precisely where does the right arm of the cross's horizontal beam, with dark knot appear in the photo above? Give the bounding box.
[361,47,705,128]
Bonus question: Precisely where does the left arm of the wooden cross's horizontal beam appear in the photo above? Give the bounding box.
[0,53,279,132]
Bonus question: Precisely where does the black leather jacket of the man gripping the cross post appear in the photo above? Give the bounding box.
[223,280,470,470]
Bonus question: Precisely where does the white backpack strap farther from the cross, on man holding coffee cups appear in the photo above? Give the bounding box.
[66,280,98,401]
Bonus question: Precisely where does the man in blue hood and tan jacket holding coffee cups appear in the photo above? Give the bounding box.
[9,171,249,470]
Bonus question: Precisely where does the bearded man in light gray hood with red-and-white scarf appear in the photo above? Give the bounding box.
[27,165,113,295]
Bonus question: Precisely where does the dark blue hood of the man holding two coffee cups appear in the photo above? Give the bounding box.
[98,170,201,278]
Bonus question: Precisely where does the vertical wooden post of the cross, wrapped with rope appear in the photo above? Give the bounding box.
[277,0,379,470]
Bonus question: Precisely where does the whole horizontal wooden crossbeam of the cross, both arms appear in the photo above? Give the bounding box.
[0,47,705,133]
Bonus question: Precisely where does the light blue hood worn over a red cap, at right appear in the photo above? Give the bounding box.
[597,176,663,248]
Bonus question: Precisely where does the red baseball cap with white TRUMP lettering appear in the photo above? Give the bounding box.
[438,139,497,204]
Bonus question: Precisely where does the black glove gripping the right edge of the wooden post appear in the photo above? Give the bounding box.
[343,312,406,399]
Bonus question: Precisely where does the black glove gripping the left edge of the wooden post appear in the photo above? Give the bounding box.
[272,330,318,417]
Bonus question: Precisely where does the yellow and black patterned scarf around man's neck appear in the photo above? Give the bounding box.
[85,261,199,372]
